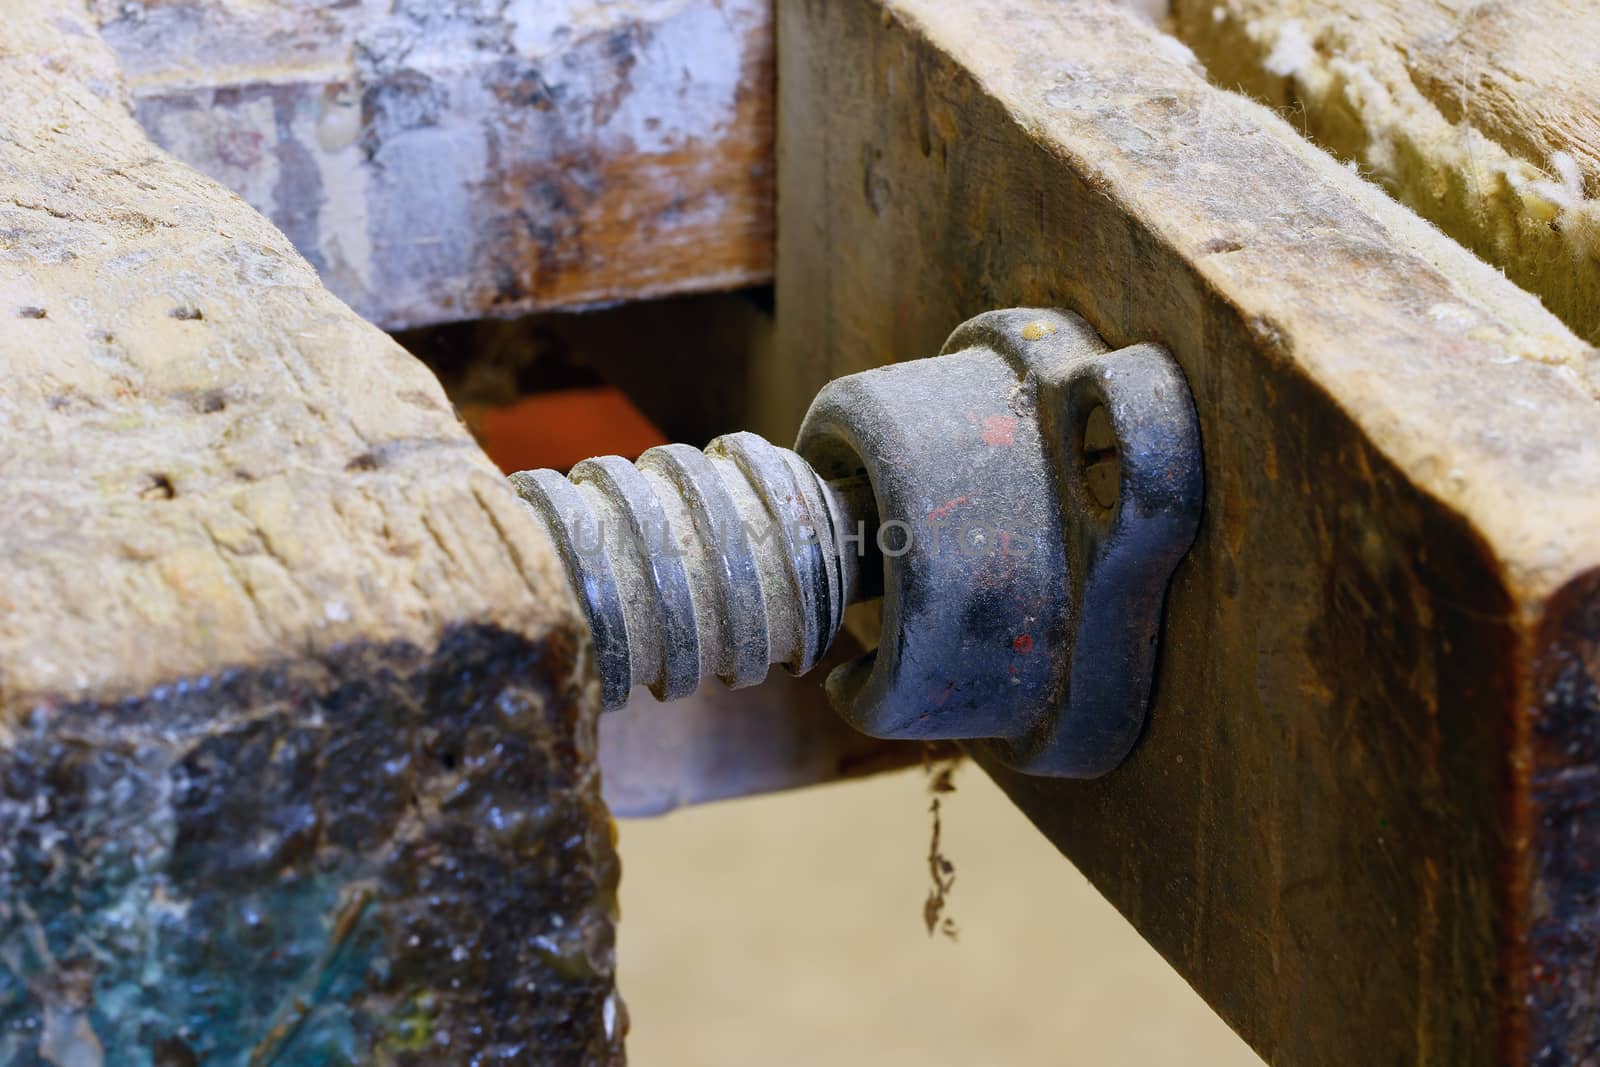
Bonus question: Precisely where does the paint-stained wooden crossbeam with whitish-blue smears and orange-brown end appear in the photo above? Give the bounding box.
[93,0,773,328]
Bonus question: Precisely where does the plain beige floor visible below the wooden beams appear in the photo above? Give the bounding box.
[619,766,1261,1067]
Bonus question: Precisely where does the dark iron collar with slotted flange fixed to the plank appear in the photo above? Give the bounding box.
[797,309,1203,777]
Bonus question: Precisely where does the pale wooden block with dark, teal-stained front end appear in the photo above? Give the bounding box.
[0,0,621,1067]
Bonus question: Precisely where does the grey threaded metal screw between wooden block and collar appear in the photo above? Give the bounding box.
[510,434,872,709]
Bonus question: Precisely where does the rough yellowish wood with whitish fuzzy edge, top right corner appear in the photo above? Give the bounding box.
[1173,0,1600,342]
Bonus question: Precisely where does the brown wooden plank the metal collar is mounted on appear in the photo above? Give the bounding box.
[768,0,1600,1065]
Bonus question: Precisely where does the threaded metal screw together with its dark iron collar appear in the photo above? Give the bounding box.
[512,309,1202,777]
